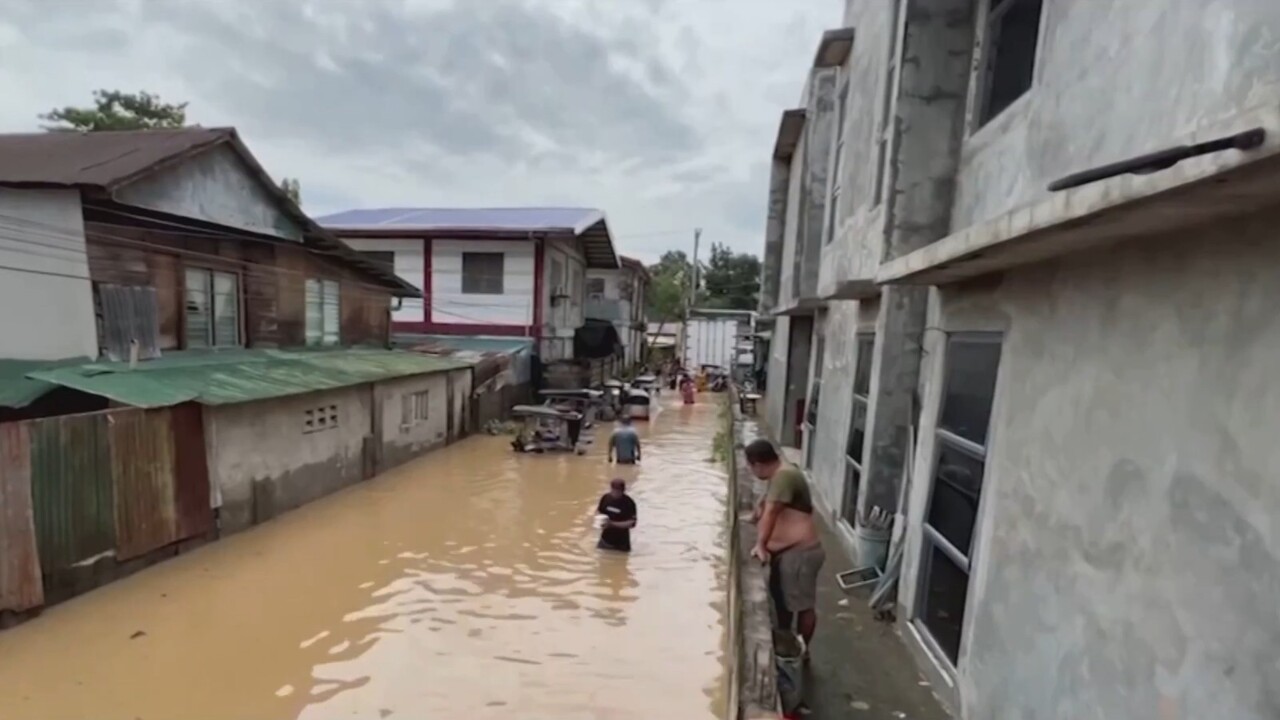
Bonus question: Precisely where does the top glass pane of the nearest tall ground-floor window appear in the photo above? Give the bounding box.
[938,336,1000,445]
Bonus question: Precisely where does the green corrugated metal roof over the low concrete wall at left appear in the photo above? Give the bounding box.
[27,348,470,407]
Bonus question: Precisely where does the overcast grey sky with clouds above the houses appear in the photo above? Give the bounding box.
[0,0,842,261]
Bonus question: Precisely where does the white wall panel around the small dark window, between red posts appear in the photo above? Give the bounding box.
[429,240,534,327]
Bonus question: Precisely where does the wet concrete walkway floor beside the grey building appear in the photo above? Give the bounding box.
[805,512,950,720]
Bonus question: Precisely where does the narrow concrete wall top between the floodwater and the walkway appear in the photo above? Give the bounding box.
[727,391,781,720]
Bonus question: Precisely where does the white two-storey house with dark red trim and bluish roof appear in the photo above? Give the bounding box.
[319,208,621,361]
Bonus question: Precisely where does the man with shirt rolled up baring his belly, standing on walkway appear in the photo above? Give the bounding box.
[744,438,827,659]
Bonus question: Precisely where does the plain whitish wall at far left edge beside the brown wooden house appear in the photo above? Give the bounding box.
[0,188,97,360]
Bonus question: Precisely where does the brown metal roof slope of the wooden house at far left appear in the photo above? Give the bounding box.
[0,128,236,188]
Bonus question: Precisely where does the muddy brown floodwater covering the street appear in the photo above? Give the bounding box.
[0,396,727,720]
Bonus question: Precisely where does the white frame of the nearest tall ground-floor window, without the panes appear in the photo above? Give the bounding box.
[911,332,1005,671]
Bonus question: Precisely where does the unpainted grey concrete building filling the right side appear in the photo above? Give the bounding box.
[762,0,1280,720]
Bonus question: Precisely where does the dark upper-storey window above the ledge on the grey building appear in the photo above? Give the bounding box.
[977,0,1044,127]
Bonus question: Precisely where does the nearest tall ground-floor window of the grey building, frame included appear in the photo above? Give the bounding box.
[915,333,1001,664]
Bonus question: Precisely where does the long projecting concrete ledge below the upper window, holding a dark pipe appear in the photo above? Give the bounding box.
[876,105,1280,284]
